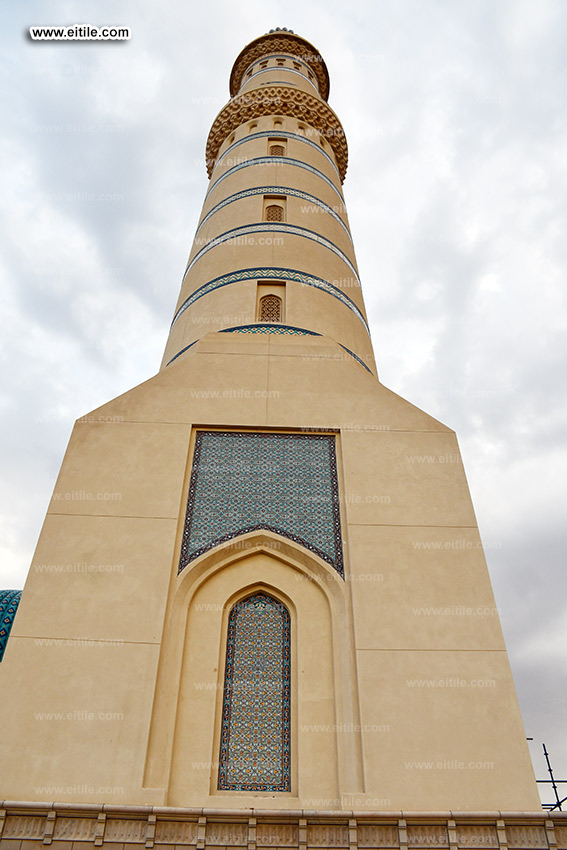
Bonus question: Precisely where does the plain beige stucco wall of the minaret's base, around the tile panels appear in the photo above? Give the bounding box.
[0,333,537,810]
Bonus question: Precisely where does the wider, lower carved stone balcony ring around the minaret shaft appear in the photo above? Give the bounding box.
[205,86,348,182]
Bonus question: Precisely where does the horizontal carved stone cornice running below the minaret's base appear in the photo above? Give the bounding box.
[0,802,567,850]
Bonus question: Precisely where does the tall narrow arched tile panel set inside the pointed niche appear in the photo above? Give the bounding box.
[218,593,291,791]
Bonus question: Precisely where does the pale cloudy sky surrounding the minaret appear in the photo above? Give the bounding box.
[0,0,567,795]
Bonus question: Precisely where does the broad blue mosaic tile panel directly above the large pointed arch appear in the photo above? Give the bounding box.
[179,431,343,576]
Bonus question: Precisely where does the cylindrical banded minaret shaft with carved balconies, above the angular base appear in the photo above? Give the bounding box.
[162,30,375,373]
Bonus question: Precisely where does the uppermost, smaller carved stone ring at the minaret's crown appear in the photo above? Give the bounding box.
[230,33,329,100]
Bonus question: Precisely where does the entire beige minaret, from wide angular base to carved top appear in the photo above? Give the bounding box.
[0,30,552,836]
